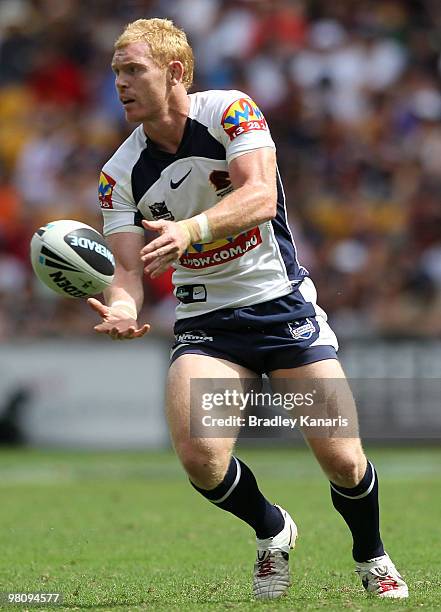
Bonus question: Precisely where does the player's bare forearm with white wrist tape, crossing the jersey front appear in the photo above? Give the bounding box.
[182,185,277,243]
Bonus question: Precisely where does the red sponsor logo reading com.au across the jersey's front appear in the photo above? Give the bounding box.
[179,227,262,269]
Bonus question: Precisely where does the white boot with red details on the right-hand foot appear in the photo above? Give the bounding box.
[355,553,409,599]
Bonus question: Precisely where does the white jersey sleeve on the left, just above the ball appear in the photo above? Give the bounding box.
[98,169,144,236]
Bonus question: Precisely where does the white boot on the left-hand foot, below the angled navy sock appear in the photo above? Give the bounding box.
[253,506,297,599]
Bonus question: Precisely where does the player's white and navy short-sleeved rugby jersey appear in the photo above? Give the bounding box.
[99,91,307,319]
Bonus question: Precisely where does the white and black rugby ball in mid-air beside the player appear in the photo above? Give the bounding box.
[31,219,115,298]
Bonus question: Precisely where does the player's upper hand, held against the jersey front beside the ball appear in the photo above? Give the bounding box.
[141,220,190,278]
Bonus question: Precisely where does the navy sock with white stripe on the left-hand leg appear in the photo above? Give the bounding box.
[190,457,284,538]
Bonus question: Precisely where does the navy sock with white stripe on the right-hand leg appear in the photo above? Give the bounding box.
[331,461,384,562]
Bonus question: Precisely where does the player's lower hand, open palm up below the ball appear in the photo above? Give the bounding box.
[87,298,150,340]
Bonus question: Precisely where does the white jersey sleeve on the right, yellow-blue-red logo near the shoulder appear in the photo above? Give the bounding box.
[221,92,275,162]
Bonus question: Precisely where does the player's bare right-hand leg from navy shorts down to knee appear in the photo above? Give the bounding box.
[270,359,366,486]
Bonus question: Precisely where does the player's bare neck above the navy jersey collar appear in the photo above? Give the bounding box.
[142,94,190,153]
